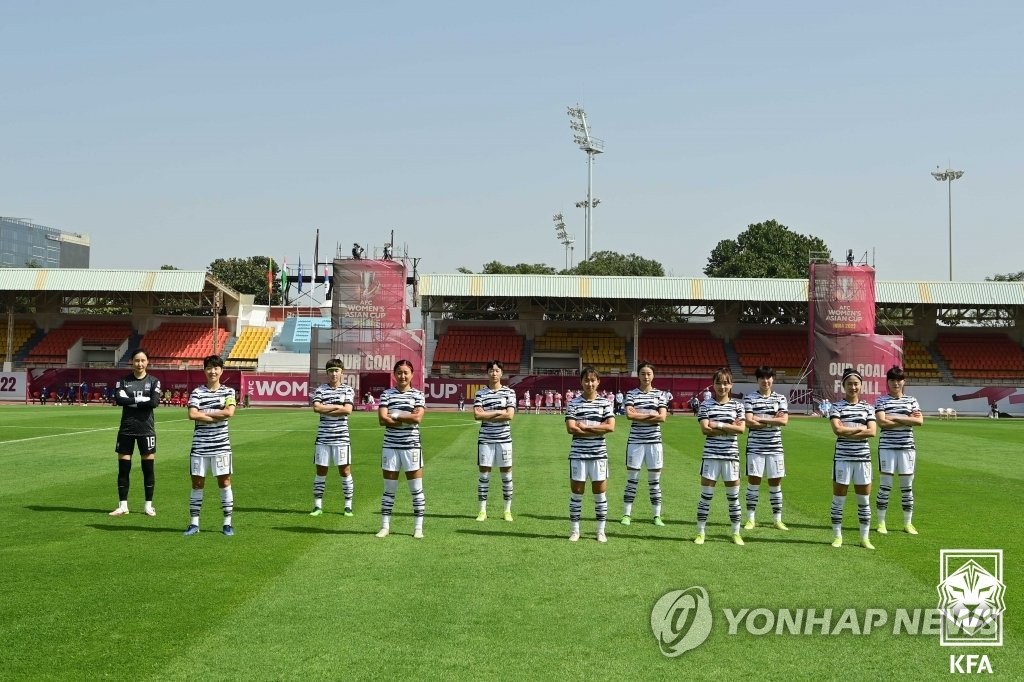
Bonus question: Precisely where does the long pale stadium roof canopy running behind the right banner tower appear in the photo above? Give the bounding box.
[419,274,1024,307]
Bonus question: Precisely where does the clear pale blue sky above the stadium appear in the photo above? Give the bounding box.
[0,0,1024,281]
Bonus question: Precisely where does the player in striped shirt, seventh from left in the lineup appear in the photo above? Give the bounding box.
[615,361,668,525]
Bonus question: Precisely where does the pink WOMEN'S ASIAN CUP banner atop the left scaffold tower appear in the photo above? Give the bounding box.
[332,258,406,329]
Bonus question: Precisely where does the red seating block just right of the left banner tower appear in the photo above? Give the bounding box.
[431,327,523,375]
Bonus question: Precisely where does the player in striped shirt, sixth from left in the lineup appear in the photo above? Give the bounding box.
[565,366,615,543]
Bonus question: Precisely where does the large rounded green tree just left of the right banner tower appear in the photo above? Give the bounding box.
[703,220,831,279]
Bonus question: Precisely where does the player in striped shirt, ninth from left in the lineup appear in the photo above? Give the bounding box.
[743,367,790,530]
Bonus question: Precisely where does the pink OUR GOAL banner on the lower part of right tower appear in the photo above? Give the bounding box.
[814,334,903,402]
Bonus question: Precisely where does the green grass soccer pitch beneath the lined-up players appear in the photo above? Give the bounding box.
[0,406,1024,680]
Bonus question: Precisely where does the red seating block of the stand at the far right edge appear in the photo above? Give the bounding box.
[935,333,1024,381]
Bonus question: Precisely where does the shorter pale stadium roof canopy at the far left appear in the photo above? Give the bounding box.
[0,267,240,310]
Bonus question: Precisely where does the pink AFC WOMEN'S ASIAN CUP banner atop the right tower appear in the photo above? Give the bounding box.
[808,263,874,334]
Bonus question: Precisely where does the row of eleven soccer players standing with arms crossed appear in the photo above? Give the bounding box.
[111,348,923,549]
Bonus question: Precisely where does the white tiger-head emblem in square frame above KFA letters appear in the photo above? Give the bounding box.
[938,550,1007,646]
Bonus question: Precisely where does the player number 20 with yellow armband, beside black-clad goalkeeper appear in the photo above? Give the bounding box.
[184,355,238,537]
